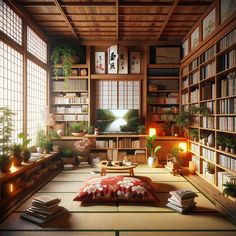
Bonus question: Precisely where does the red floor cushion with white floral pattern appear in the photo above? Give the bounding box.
[74,175,158,203]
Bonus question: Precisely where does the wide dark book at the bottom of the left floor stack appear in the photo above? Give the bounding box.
[20,207,68,226]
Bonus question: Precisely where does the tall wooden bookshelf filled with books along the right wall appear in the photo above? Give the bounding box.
[180,28,236,195]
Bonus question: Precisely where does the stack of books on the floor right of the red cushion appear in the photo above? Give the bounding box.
[166,190,198,214]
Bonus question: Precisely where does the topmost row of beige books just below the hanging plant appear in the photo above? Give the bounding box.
[52,79,88,91]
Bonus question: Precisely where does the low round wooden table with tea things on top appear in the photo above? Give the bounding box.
[98,161,138,176]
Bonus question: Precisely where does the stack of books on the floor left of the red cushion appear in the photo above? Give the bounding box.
[20,195,68,226]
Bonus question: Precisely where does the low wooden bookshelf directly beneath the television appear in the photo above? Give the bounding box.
[86,134,147,163]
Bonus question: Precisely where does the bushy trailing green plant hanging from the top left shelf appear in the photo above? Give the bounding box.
[51,43,84,78]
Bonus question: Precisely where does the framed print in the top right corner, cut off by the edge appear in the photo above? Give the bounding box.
[220,0,236,24]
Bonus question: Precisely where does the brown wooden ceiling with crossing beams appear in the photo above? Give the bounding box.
[17,0,212,41]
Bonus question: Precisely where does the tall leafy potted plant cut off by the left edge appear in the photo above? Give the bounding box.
[0,107,14,172]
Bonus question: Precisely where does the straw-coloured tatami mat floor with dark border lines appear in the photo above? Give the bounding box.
[0,167,236,236]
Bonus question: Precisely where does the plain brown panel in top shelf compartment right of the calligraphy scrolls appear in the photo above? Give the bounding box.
[156,47,180,64]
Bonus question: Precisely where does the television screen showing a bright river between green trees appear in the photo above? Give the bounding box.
[96,109,139,133]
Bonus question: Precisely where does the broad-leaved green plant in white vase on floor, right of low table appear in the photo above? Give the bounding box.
[146,134,161,168]
